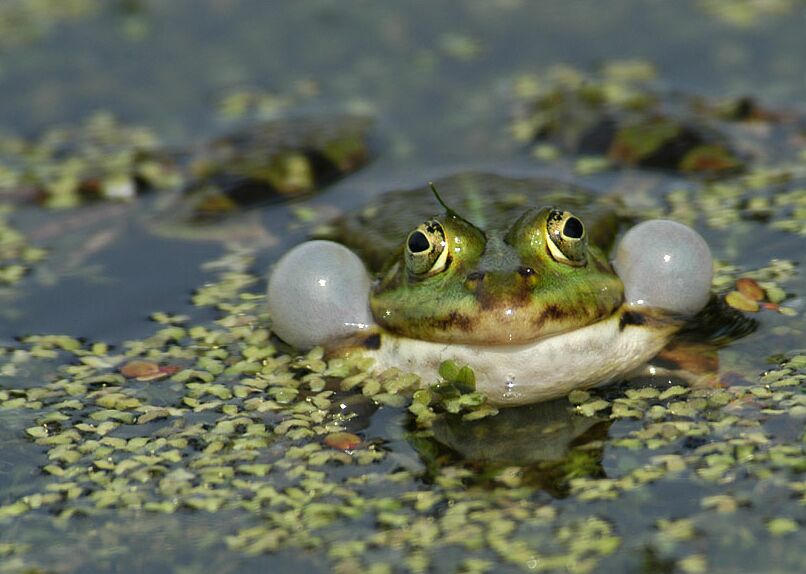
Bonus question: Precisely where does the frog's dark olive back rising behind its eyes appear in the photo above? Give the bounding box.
[329,172,617,271]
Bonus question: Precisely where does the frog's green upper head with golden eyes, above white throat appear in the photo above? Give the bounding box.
[370,194,624,345]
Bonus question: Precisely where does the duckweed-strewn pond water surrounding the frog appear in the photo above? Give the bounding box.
[0,0,806,574]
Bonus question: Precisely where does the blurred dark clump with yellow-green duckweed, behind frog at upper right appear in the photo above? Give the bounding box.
[512,61,760,176]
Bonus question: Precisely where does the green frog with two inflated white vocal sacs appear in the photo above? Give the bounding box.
[267,172,712,407]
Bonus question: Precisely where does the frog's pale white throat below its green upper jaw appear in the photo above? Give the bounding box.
[366,305,682,406]
